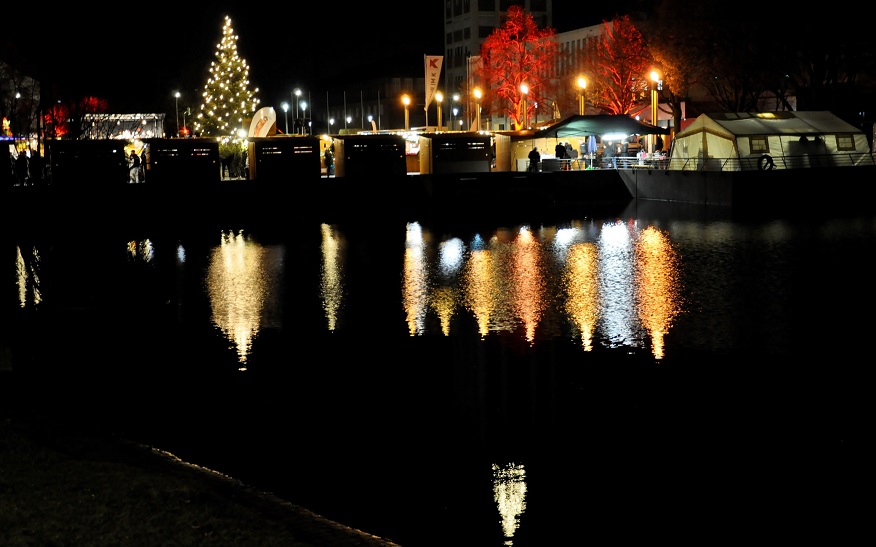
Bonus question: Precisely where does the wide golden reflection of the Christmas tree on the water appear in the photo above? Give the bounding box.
[207,231,283,370]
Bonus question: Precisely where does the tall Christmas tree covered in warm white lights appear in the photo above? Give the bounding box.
[194,16,259,137]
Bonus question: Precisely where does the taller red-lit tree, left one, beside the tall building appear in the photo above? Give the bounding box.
[476,6,559,129]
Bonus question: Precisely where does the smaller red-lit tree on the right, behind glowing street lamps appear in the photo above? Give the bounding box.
[587,15,651,114]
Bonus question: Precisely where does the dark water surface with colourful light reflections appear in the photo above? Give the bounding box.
[0,199,876,547]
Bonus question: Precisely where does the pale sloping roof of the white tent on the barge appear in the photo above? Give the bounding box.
[676,111,861,137]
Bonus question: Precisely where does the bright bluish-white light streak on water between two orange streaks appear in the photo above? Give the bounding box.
[597,221,641,346]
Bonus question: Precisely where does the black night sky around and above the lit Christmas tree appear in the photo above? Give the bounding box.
[0,0,614,112]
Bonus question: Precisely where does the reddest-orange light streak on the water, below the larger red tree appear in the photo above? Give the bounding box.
[511,226,544,344]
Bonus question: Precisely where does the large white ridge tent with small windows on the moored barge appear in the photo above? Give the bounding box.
[670,111,873,171]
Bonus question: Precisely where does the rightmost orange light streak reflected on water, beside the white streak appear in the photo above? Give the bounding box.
[636,226,681,359]
